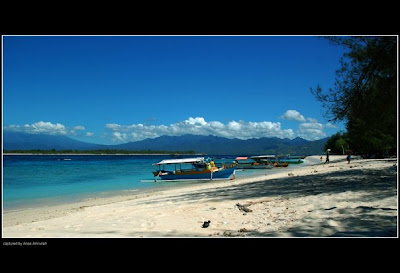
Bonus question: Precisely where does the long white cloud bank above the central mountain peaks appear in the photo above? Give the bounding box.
[106,117,295,142]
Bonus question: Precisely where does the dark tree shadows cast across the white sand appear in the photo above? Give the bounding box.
[144,162,397,237]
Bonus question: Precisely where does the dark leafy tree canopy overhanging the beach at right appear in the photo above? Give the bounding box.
[311,36,397,154]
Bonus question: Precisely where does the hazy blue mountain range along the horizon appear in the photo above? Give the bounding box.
[3,131,327,155]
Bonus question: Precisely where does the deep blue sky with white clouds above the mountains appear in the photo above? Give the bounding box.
[2,36,344,144]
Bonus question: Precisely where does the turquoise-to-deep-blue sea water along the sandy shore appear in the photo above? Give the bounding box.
[2,155,310,210]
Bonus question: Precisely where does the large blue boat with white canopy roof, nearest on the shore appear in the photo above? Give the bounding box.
[153,157,236,181]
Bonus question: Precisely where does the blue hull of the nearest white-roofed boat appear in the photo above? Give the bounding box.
[156,168,236,181]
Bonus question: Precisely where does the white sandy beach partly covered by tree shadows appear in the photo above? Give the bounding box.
[3,156,398,238]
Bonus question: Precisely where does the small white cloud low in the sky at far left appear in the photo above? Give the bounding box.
[3,121,85,135]
